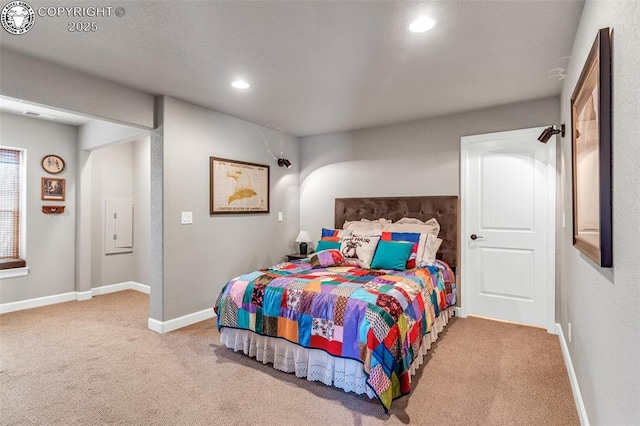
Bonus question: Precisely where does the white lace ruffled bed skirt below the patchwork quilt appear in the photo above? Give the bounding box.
[220,307,454,398]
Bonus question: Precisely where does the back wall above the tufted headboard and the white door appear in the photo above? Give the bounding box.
[300,98,560,240]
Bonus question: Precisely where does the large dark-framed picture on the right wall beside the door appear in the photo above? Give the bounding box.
[571,28,613,267]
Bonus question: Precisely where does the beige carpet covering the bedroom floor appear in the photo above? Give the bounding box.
[0,291,579,425]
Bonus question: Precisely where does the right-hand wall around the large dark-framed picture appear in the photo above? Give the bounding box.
[559,0,640,425]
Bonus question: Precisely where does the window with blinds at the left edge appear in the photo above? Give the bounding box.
[0,147,25,269]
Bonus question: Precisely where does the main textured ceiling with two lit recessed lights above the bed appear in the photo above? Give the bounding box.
[0,0,583,137]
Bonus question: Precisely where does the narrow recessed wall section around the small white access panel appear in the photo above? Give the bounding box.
[91,143,137,288]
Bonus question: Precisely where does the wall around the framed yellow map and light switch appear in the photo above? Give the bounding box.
[159,97,299,321]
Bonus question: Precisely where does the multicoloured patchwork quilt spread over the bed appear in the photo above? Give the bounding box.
[214,259,456,411]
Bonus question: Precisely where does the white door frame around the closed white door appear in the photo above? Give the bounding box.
[459,126,557,334]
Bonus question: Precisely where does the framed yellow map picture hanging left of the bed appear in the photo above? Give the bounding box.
[209,157,269,214]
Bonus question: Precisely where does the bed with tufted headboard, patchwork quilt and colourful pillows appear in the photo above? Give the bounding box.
[214,196,458,412]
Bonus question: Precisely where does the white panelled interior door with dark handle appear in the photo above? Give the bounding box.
[461,127,555,333]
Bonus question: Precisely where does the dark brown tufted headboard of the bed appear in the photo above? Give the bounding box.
[335,195,458,267]
